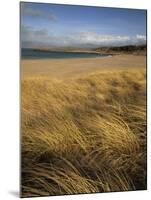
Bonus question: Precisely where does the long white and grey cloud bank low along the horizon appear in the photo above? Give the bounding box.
[21,26,146,48]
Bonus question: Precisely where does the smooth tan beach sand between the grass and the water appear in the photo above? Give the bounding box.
[21,55,146,79]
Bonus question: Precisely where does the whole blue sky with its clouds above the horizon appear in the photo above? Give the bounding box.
[21,2,146,48]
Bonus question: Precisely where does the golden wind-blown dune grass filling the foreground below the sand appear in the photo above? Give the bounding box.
[21,69,147,197]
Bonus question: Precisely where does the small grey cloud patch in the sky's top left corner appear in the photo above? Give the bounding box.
[21,3,57,21]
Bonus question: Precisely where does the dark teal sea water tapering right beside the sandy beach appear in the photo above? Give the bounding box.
[21,49,109,59]
